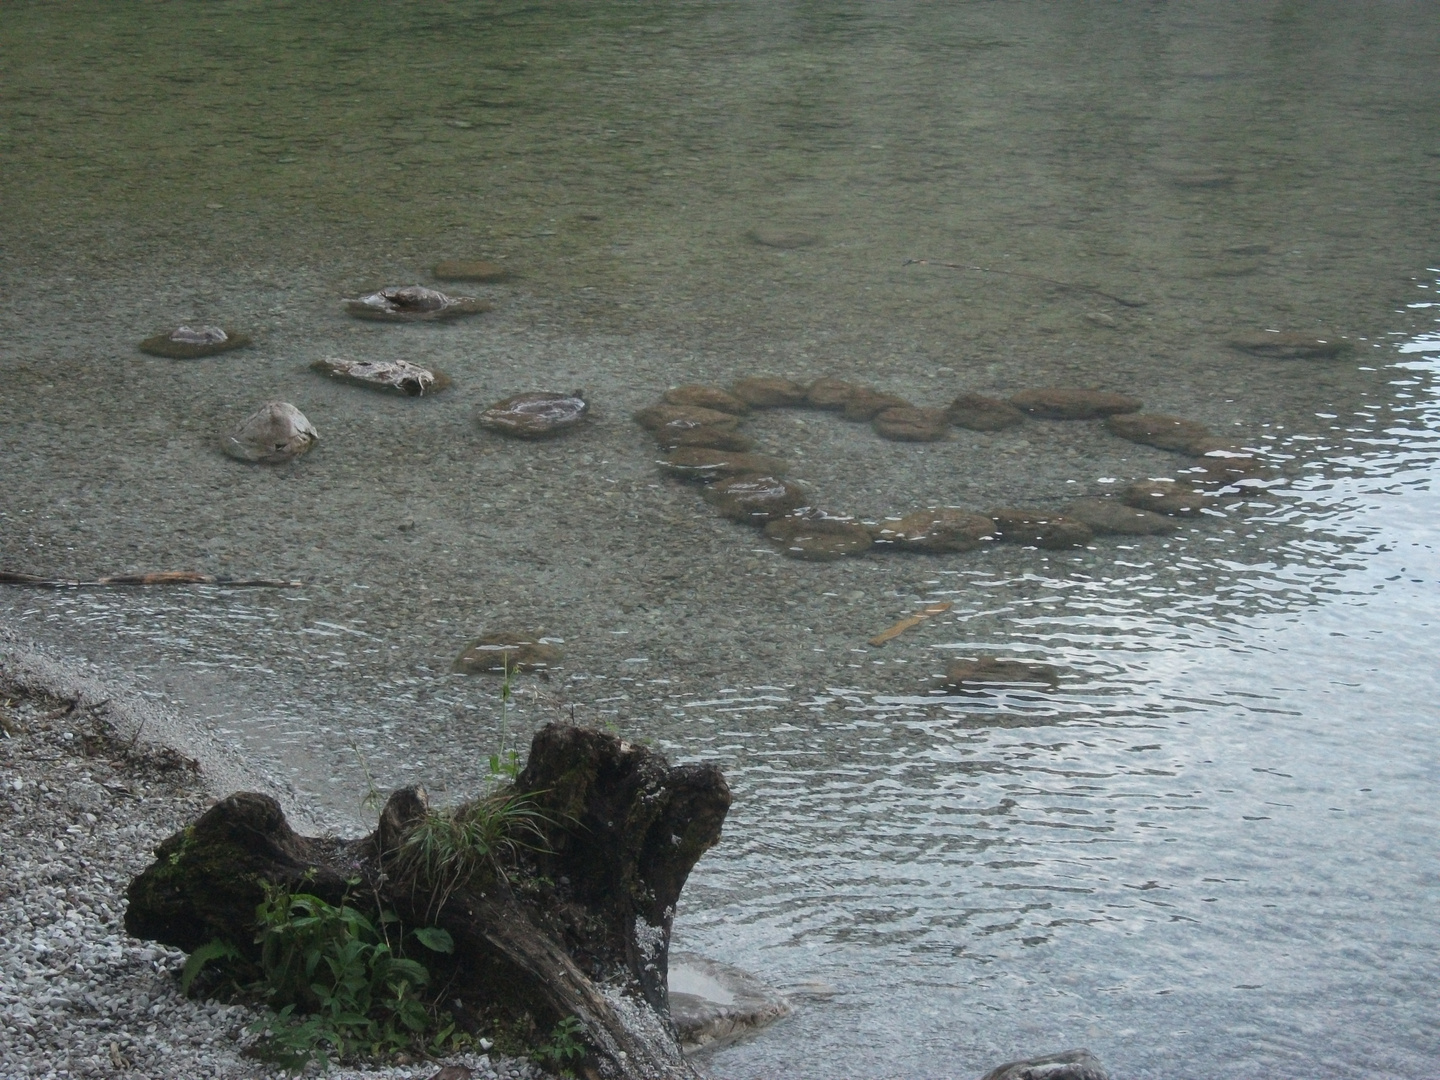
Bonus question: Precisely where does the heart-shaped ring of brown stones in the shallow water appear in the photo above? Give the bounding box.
[635,376,1261,562]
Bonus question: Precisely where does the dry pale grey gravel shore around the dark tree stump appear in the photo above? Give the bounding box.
[0,674,540,1080]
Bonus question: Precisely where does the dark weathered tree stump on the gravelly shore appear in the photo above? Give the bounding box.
[125,724,730,1080]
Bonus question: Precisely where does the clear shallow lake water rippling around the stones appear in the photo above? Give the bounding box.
[0,4,1440,1077]
